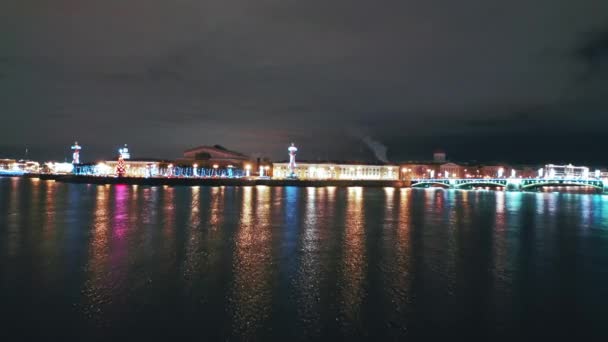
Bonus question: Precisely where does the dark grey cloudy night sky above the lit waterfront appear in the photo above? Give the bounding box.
[0,0,608,165]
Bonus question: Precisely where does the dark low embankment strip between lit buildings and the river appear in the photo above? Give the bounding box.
[17,174,409,188]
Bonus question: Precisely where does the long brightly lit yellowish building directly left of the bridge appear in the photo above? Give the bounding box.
[272,162,399,180]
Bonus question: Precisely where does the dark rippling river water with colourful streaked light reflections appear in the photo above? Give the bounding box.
[0,178,608,341]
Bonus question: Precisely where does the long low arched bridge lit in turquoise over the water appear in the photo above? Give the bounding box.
[411,178,608,192]
